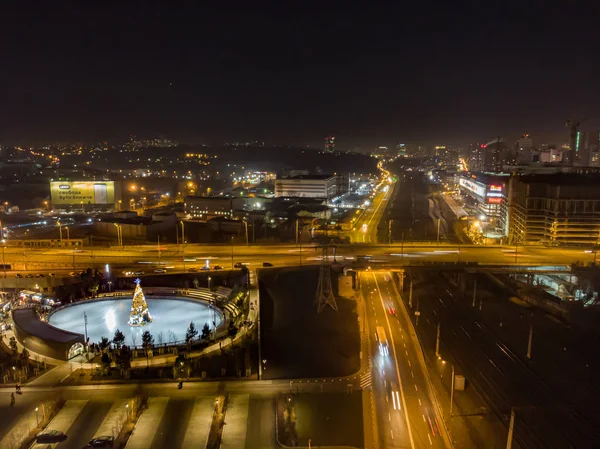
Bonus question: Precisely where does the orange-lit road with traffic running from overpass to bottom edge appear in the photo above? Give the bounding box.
[360,273,447,449]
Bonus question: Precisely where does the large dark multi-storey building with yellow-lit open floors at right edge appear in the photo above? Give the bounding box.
[508,169,600,246]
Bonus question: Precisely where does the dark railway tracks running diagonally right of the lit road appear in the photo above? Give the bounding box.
[404,273,595,448]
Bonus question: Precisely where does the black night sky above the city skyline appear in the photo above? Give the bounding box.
[0,0,600,148]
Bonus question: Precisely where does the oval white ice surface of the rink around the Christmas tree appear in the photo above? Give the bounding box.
[49,297,222,346]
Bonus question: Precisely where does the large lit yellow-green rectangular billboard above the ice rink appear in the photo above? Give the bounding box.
[50,181,115,205]
